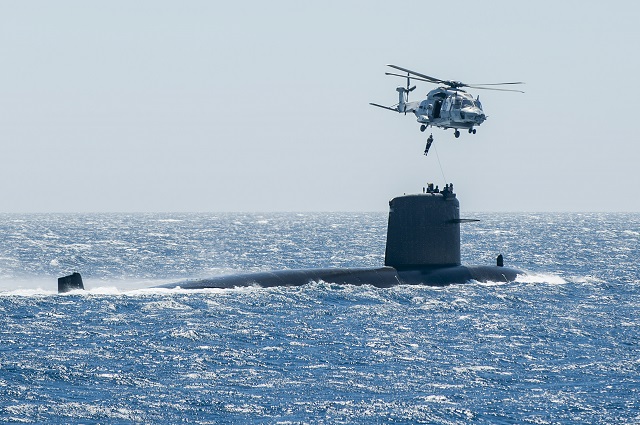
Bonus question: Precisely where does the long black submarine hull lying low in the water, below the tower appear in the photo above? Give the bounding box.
[157,265,521,289]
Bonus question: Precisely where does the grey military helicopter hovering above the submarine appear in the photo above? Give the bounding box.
[369,65,524,138]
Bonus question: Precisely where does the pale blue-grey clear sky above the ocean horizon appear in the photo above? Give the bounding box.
[0,0,640,213]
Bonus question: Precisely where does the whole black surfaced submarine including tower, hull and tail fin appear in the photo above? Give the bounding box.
[58,184,523,293]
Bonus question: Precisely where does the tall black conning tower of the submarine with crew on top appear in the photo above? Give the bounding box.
[384,185,461,270]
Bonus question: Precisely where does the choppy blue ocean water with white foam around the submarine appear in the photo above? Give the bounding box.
[0,213,640,424]
